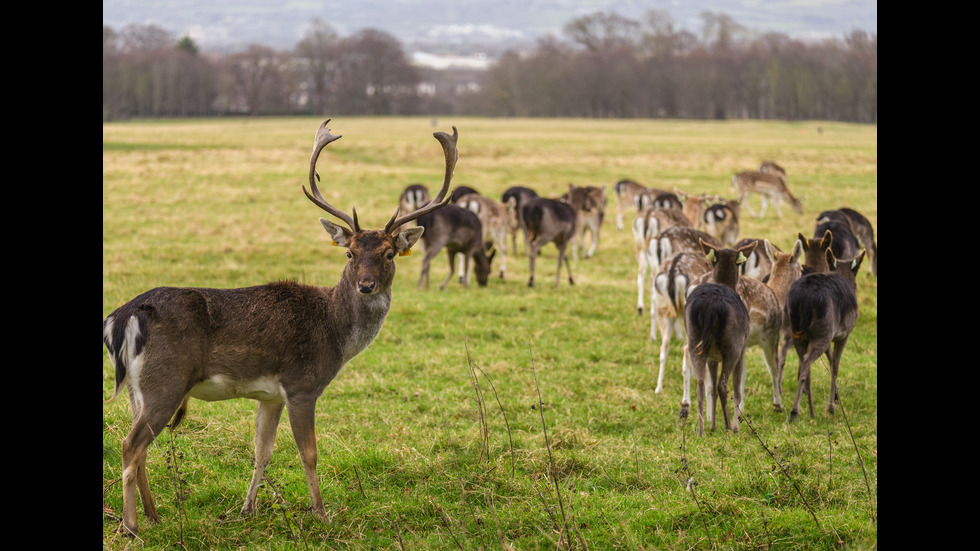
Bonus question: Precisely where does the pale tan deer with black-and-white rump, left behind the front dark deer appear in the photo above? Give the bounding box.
[650,252,712,394]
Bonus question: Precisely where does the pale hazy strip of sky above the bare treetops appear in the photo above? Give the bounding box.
[102,0,878,52]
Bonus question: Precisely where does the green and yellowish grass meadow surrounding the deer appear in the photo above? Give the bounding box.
[102,117,880,550]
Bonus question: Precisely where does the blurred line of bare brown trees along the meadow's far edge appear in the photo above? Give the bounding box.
[102,10,878,123]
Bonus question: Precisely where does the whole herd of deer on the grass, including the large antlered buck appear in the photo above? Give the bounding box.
[103,120,878,535]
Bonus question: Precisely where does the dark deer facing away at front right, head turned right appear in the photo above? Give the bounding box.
[785,250,864,421]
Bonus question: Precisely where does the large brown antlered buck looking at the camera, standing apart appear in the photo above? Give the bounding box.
[102,120,457,535]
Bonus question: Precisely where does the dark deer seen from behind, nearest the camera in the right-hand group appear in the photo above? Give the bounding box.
[681,242,751,436]
